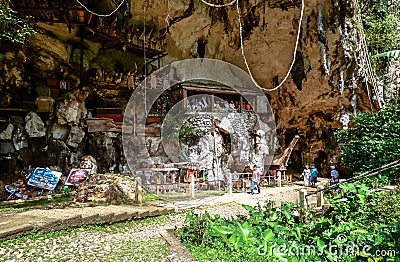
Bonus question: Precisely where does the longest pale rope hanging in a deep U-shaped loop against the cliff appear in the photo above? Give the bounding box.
[236,0,304,92]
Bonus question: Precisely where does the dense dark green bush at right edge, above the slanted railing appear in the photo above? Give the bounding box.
[335,106,400,172]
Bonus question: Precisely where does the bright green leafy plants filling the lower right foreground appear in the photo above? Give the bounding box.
[181,186,400,261]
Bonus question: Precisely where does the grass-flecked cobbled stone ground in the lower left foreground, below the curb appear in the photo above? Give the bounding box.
[0,213,184,261]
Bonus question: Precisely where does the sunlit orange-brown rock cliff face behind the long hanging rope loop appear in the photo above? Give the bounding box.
[131,0,377,175]
